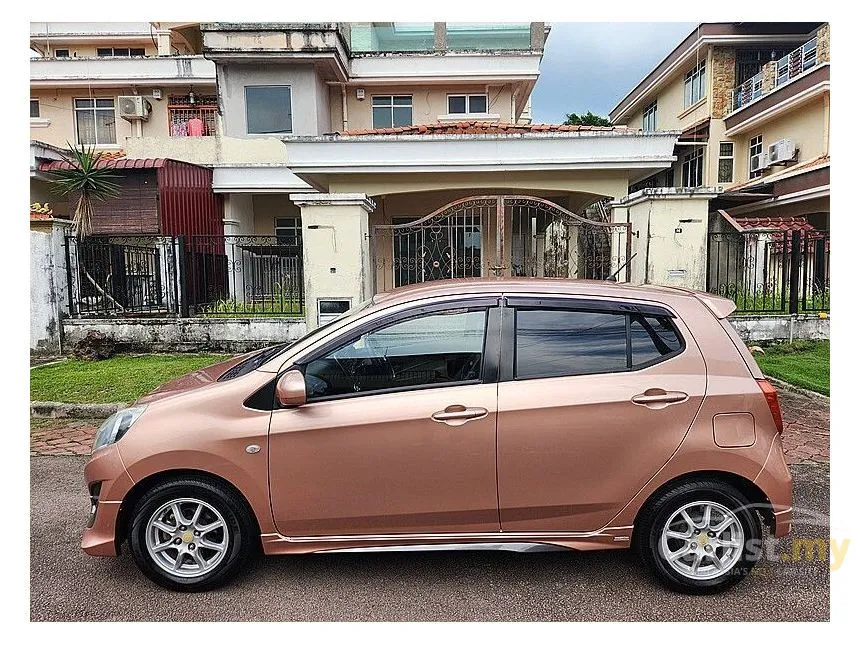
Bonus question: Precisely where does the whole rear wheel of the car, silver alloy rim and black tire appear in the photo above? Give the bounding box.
[634,480,762,594]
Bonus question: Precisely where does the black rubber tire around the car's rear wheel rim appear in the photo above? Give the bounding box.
[633,479,762,595]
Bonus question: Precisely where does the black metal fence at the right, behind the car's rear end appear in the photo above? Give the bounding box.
[707,230,830,314]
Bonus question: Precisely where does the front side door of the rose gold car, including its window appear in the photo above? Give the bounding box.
[269,298,500,536]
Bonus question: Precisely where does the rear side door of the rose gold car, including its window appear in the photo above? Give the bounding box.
[498,298,706,532]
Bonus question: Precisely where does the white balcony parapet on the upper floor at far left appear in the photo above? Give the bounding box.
[30,56,215,87]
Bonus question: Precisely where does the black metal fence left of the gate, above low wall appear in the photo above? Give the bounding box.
[66,235,304,317]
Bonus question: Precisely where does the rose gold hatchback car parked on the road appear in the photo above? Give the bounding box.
[82,279,791,593]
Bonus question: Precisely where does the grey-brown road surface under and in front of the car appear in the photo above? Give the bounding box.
[30,457,830,621]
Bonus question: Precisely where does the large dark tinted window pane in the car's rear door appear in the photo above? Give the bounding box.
[514,309,627,378]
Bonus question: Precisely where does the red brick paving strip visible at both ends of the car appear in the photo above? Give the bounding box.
[30,390,830,464]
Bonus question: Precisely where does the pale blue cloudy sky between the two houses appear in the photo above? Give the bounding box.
[532,22,697,123]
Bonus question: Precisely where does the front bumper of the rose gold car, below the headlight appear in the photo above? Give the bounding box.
[81,444,134,556]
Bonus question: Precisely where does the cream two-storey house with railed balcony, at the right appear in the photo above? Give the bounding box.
[610,23,830,228]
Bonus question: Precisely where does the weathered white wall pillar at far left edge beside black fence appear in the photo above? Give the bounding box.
[30,218,72,355]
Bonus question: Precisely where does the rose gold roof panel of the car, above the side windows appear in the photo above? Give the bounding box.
[373,278,710,305]
